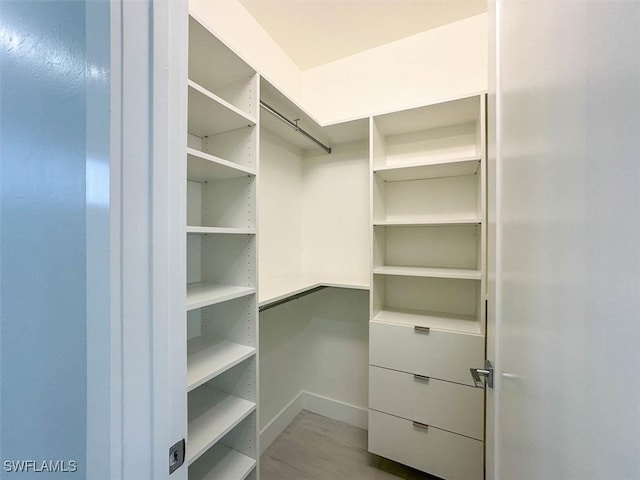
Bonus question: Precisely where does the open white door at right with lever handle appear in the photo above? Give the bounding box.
[489,1,640,480]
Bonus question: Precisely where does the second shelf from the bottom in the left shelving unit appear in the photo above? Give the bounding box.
[187,390,256,465]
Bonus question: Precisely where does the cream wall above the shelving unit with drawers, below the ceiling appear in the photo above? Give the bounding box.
[303,14,488,123]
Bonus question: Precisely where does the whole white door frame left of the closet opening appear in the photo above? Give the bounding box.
[95,0,188,480]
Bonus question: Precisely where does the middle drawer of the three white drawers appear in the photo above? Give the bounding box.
[369,367,484,440]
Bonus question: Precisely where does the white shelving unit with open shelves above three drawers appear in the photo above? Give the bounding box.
[369,95,486,480]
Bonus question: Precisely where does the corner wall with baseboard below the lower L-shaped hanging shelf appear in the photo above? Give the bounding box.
[260,288,369,449]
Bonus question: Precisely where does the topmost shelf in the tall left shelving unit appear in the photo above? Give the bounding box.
[188,80,256,137]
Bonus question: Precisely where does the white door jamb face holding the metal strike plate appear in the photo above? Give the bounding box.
[150,0,188,480]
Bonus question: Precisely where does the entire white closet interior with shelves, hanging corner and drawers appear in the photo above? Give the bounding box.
[186,2,487,480]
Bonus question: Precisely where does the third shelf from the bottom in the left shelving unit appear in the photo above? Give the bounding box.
[187,337,256,392]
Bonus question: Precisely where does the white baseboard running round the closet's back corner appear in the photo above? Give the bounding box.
[260,391,369,455]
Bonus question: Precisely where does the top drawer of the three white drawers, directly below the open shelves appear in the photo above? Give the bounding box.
[369,322,484,386]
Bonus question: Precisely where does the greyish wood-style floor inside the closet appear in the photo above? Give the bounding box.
[260,410,436,480]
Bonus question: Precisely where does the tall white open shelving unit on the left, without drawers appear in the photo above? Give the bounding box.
[185,15,259,480]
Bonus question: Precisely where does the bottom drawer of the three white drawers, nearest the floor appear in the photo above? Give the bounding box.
[369,410,484,480]
